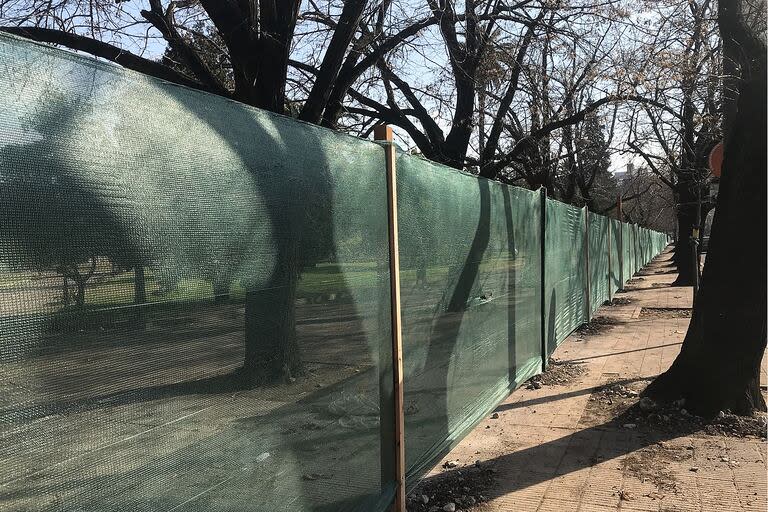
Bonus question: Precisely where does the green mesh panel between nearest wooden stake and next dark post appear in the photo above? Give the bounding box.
[397,155,541,481]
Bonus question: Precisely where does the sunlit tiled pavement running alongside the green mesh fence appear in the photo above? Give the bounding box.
[420,251,768,512]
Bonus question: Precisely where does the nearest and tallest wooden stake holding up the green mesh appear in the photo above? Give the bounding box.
[373,124,406,512]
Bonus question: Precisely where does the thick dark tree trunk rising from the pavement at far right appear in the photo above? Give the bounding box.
[645,39,768,416]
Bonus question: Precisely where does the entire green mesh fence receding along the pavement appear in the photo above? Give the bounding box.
[0,34,666,512]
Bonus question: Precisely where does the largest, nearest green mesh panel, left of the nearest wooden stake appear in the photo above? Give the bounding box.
[0,36,393,512]
